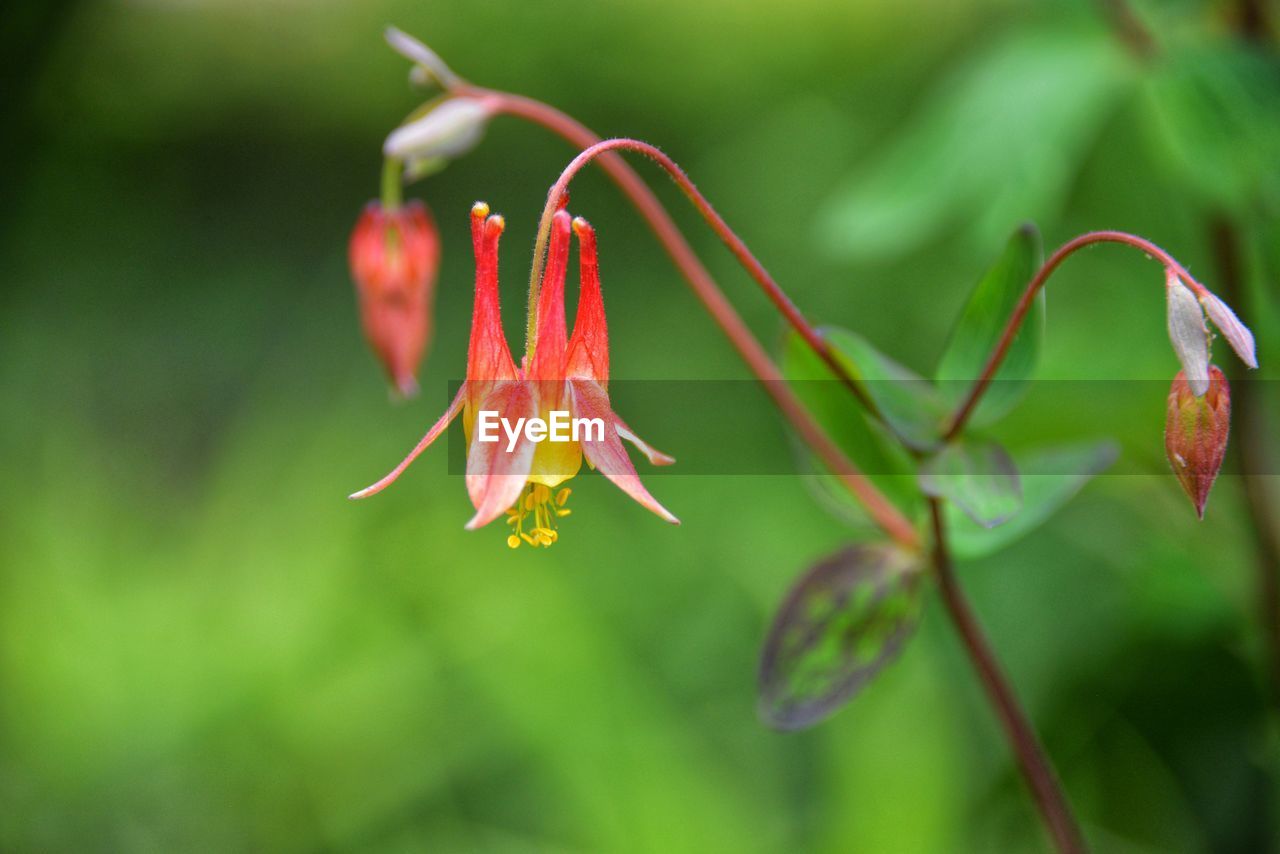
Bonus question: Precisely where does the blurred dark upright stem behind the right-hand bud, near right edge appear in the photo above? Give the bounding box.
[1210,218,1280,707]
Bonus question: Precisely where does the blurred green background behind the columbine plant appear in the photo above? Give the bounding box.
[0,0,1280,851]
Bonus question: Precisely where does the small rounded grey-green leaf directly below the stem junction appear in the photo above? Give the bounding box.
[920,439,1023,528]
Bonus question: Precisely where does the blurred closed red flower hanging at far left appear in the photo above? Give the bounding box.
[349,201,440,397]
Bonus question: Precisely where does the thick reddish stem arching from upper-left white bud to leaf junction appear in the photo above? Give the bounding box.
[454,87,920,549]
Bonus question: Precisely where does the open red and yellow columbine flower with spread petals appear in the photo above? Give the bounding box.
[352,202,678,548]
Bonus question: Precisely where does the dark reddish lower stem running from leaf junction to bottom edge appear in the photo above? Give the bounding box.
[929,498,1087,854]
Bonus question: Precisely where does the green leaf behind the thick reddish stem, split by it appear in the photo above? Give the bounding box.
[781,332,919,525]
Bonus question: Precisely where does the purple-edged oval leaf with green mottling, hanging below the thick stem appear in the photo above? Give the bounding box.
[759,544,922,730]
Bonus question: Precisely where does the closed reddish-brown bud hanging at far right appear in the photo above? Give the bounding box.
[1165,365,1231,519]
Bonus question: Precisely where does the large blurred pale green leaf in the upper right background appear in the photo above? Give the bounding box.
[819,27,1132,261]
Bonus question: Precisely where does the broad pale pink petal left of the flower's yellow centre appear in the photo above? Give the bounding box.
[466,382,538,530]
